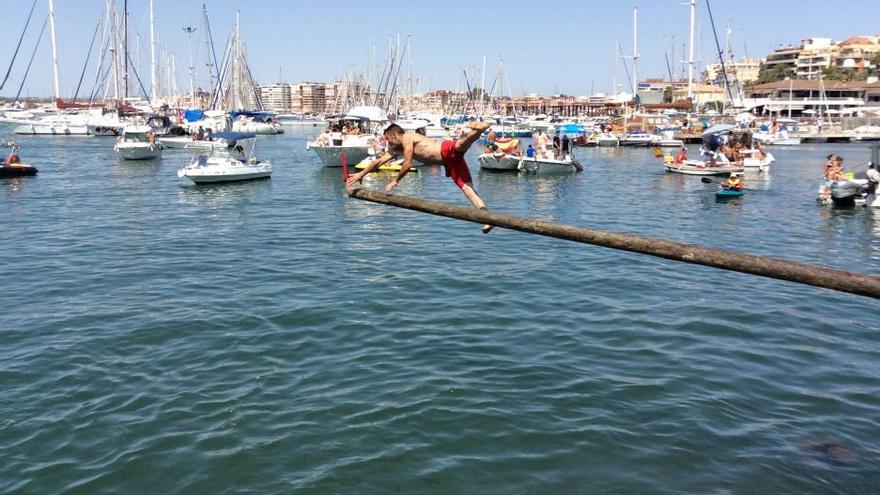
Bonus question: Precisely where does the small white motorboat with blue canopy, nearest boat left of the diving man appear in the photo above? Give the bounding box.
[177,133,272,184]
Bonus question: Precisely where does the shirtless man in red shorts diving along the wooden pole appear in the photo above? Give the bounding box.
[346,122,492,234]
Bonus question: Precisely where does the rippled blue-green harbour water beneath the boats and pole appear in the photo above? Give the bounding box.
[0,132,880,494]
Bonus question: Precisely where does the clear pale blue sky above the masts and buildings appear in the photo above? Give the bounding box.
[0,0,880,97]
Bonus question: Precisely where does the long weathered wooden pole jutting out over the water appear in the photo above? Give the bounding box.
[349,189,880,299]
